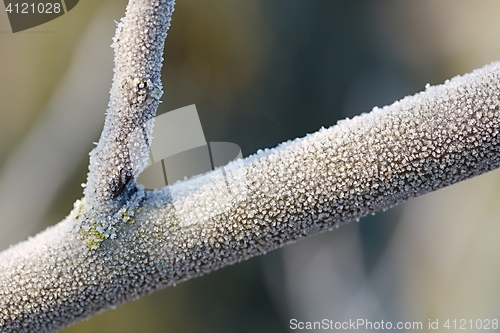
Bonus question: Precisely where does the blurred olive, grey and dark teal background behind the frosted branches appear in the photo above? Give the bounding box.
[0,0,500,333]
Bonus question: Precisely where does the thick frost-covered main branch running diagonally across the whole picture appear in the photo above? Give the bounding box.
[0,63,500,332]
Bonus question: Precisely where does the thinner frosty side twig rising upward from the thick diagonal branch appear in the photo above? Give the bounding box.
[85,0,174,212]
